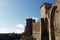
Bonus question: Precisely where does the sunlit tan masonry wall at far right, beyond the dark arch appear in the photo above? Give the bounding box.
[54,0,60,40]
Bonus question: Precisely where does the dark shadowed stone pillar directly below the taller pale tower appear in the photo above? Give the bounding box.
[41,18,49,40]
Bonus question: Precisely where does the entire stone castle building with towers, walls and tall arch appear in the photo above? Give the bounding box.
[25,0,60,40]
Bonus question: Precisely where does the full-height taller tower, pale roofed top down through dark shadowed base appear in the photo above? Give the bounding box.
[40,3,52,40]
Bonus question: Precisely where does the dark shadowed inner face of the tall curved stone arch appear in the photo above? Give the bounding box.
[50,6,57,40]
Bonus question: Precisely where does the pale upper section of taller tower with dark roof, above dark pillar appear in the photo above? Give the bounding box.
[40,3,52,18]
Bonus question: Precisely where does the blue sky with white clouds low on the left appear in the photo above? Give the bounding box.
[0,0,56,33]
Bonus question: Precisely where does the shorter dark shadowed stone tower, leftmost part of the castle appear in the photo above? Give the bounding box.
[25,18,35,36]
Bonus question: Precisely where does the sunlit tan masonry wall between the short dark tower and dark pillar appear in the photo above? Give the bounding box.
[33,21,41,40]
